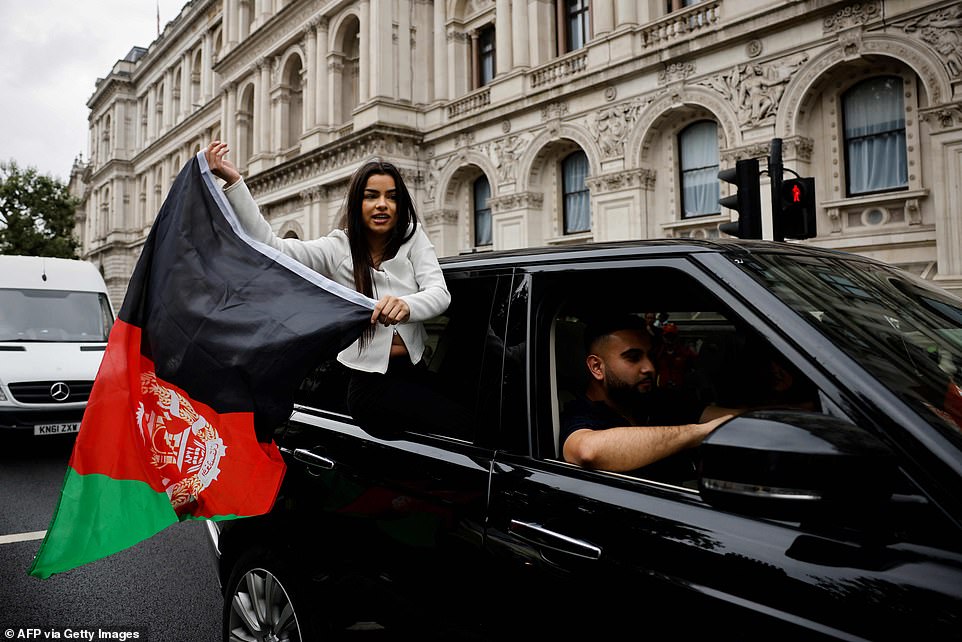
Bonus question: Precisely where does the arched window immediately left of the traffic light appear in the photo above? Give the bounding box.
[678,120,721,218]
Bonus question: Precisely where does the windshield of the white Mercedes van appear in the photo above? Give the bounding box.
[0,288,113,342]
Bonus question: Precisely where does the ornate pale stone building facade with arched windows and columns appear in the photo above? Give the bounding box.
[71,0,962,304]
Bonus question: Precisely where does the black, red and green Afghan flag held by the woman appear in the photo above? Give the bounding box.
[29,152,374,578]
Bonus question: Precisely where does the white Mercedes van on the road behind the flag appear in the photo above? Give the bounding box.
[0,256,114,436]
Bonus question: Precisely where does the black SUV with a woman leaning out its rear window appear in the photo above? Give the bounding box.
[209,240,962,641]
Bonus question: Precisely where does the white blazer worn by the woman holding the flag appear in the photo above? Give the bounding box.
[224,179,451,372]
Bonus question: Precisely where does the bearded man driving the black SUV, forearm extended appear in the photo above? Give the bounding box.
[561,315,738,479]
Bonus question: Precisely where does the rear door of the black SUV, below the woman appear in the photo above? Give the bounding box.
[274,271,504,627]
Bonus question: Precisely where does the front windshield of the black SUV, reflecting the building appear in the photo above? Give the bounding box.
[746,254,962,440]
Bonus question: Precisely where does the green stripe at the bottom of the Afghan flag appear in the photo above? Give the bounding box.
[28,468,177,579]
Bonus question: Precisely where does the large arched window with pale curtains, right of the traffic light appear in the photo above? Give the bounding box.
[842,76,908,196]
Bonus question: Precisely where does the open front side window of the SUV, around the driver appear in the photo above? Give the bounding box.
[539,268,821,484]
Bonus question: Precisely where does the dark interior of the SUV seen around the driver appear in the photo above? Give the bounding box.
[548,264,818,470]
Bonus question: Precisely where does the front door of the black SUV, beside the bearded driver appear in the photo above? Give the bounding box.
[486,257,962,640]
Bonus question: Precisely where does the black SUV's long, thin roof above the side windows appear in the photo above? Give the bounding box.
[439,238,877,269]
